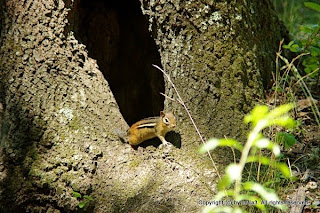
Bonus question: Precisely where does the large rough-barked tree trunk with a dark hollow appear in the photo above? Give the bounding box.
[0,0,280,212]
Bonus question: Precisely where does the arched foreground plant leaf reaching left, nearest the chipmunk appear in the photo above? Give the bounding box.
[199,138,243,153]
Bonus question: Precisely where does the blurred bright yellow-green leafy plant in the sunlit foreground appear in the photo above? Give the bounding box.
[199,104,296,213]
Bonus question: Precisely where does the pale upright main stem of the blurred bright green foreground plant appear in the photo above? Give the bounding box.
[234,119,267,199]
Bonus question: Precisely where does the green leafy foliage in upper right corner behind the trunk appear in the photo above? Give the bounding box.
[274,0,320,79]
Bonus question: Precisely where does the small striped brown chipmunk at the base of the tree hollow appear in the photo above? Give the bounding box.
[117,111,176,146]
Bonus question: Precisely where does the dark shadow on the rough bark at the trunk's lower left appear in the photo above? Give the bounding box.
[0,101,50,212]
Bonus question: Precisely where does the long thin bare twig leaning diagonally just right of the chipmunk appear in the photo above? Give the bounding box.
[152,64,221,179]
